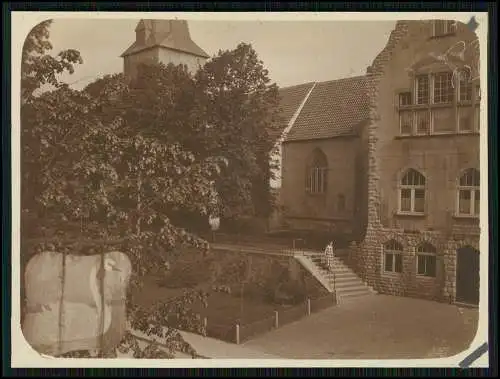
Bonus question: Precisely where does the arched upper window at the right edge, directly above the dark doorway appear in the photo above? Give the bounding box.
[457,168,479,216]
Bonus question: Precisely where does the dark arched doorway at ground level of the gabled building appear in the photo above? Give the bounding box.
[456,246,479,305]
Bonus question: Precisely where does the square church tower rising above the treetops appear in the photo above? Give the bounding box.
[121,20,209,79]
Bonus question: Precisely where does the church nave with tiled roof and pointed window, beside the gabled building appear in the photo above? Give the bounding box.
[272,76,368,239]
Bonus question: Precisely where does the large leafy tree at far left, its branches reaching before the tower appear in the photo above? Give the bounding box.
[21,23,218,357]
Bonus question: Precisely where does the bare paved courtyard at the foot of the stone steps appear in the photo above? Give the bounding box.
[243,295,478,359]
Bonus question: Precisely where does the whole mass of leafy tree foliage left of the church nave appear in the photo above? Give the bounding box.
[21,21,277,356]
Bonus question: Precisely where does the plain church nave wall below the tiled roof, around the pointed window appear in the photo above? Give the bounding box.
[281,137,360,238]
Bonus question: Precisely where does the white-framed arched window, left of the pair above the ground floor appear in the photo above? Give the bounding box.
[399,168,425,214]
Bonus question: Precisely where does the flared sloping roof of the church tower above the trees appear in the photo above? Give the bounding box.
[121,19,209,58]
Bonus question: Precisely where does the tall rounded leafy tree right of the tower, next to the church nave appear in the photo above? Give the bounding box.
[196,43,279,223]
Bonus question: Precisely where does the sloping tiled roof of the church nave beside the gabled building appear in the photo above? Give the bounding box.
[285,76,368,141]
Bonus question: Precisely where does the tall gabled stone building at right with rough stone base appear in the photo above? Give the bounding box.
[354,20,486,304]
